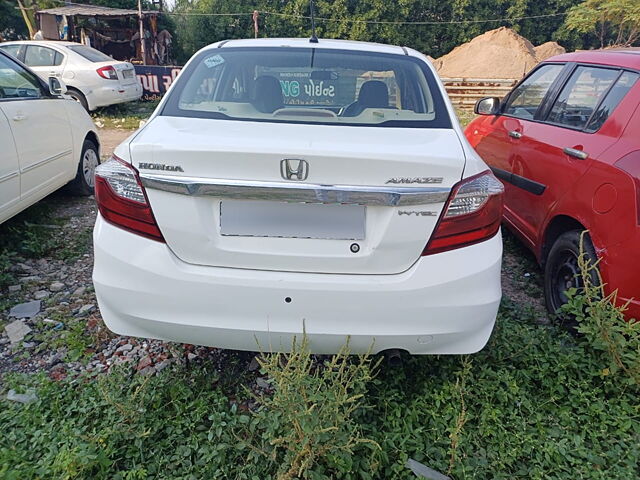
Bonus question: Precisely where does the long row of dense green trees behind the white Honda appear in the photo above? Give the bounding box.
[170,0,604,61]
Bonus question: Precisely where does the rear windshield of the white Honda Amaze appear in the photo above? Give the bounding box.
[162,47,451,128]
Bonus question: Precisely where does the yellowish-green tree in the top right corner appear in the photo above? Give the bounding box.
[566,0,640,48]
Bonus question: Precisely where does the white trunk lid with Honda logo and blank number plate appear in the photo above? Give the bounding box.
[130,116,464,274]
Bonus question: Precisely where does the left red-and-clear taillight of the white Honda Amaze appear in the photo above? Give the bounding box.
[95,155,164,242]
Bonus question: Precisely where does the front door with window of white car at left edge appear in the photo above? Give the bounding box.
[0,56,77,202]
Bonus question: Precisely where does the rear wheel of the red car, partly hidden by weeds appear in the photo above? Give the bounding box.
[544,230,600,328]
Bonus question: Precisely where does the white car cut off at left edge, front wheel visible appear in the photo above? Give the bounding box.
[0,51,100,223]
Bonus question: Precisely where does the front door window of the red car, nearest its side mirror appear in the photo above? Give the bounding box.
[504,64,564,120]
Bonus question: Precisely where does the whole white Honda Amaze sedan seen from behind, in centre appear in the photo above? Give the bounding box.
[93,39,503,354]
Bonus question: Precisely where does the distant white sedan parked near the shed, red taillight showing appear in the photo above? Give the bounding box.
[0,40,142,111]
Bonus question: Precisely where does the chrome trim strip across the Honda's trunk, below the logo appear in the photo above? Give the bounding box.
[140,174,451,207]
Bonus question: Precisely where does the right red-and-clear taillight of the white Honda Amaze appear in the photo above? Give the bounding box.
[422,171,504,255]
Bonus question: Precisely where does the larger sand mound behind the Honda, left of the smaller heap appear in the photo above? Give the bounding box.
[434,27,539,78]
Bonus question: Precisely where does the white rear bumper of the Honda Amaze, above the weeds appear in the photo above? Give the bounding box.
[93,216,502,354]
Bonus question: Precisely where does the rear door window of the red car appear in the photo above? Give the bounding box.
[547,67,620,129]
